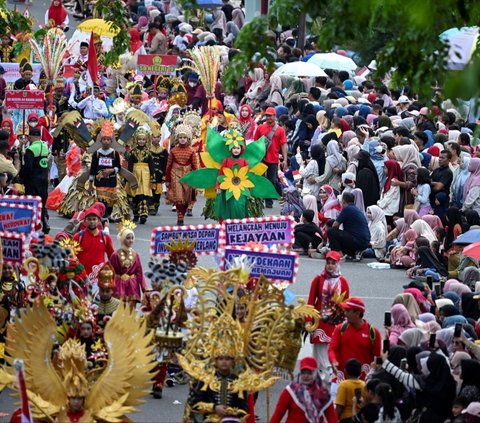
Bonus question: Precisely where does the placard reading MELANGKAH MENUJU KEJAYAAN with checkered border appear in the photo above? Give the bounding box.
[222,216,295,246]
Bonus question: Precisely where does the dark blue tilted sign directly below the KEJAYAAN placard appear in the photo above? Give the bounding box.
[223,247,298,283]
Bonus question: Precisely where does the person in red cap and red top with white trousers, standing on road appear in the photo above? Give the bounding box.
[308,251,350,381]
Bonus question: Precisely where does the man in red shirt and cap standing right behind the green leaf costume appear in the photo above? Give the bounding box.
[253,107,287,209]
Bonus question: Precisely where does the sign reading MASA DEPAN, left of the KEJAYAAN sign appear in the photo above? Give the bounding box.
[150,225,221,255]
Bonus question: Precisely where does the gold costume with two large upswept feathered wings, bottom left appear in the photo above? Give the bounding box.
[0,302,155,423]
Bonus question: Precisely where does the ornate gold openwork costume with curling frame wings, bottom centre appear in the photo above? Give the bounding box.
[177,262,319,422]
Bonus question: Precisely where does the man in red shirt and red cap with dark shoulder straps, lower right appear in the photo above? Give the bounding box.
[328,297,382,381]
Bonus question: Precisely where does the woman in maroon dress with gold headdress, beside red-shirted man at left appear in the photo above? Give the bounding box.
[110,223,147,308]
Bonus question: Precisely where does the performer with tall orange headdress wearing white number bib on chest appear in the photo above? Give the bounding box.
[88,121,120,216]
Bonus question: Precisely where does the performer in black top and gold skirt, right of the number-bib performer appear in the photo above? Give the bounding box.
[127,128,155,225]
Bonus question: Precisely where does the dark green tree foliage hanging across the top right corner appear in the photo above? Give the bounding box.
[224,0,480,101]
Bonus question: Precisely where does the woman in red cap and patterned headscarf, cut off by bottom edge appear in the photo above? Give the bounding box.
[270,357,338,423]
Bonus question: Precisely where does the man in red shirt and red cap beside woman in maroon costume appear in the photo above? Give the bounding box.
[73,207,114,276]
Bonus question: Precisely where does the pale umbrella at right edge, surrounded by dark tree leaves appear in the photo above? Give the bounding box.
[440,26,478,70]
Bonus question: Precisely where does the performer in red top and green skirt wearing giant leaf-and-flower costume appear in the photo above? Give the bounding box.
[215,133,253,222]
